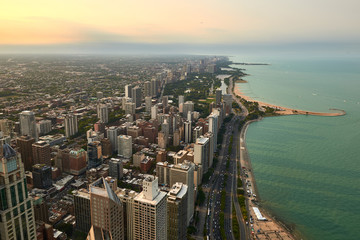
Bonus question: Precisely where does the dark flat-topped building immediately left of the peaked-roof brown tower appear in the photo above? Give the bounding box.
[74,189,91,233]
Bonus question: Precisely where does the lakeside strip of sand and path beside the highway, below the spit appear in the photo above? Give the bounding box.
[240,121,303,240]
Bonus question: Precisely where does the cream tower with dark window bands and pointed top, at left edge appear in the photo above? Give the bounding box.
[0,143,36,240]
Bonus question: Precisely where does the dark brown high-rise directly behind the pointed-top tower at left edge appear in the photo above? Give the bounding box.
[16,136,35,171]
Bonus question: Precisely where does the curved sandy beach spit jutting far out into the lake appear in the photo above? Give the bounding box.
[233,86,346,117]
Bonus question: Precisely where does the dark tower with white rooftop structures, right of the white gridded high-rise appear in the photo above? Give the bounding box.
[167,182,188,240]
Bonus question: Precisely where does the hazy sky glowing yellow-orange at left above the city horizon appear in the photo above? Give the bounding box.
[0,0,360,53]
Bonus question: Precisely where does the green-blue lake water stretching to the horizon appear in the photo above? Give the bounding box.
[231,56,360,240]
